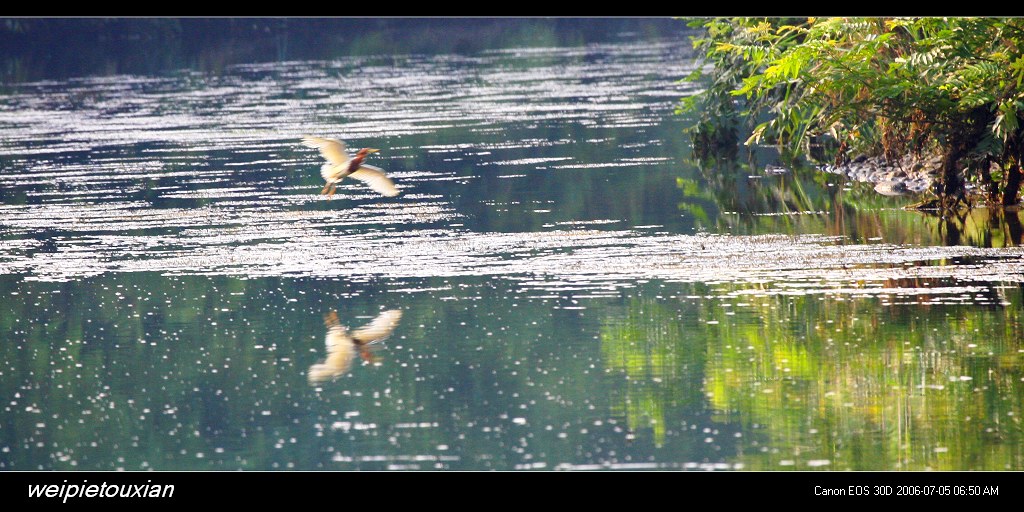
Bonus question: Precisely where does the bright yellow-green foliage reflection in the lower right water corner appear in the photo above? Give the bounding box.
[706,283,1024,469]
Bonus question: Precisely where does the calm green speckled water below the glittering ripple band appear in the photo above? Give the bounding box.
[0,273,1024,470]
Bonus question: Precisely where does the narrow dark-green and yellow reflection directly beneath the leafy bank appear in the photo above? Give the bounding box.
[677,155,1024,248]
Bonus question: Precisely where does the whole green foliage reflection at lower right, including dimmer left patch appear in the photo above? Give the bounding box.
[601,280,1024,470]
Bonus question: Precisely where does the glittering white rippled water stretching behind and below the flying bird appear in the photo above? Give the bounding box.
[0,37,1024,295]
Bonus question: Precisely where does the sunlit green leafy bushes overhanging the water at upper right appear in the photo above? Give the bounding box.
[680,17,1024,211]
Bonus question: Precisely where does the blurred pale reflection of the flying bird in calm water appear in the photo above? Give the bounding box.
[309,309,401,384]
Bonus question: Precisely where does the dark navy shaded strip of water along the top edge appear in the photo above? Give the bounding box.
[0,17,685,83]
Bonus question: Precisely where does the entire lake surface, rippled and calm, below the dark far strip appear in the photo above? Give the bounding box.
[0,19,1024,471]
